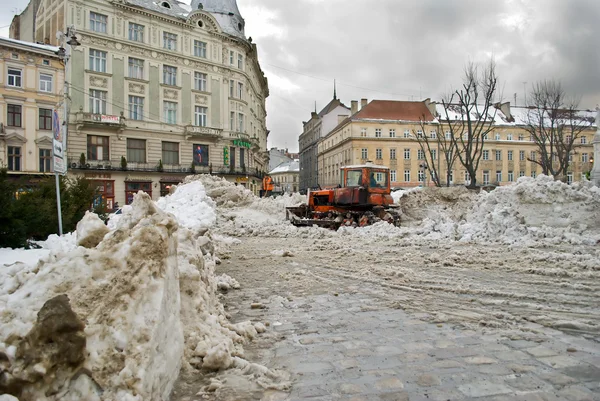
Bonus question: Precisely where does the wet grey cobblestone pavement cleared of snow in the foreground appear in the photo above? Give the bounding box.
[210,236,600,401]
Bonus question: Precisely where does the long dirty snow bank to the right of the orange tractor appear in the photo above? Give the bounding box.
[339,175,600,245]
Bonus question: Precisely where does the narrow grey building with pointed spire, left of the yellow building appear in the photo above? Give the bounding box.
[298,96,350,191]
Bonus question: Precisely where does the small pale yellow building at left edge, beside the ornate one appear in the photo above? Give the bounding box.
[0,38,64,182]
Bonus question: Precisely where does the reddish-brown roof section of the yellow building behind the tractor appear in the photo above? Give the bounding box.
[352,100,434,121]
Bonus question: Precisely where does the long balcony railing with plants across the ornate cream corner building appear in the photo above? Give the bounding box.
[68,159,265,178]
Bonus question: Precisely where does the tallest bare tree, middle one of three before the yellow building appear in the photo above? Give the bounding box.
[439,59,499,188]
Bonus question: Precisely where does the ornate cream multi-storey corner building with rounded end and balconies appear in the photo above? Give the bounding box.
[12,0,269,208]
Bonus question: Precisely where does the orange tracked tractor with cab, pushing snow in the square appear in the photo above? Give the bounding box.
[286,163,400,230]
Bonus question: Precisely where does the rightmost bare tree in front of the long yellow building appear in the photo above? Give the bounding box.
[524,81,592,181]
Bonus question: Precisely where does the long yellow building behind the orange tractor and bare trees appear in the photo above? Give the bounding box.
[318,99,595,187]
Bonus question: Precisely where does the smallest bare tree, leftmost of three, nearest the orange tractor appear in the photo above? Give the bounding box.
[413,116,458,187]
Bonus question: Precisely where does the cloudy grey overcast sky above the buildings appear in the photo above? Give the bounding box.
[0,0,600,151]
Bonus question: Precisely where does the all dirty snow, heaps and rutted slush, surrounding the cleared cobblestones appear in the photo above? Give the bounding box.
[0,175,600,401]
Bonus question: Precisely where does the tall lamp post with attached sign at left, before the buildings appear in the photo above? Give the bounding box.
[54,26,81,235]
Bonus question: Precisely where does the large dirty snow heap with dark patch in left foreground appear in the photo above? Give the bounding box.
[0,180,287,401]
